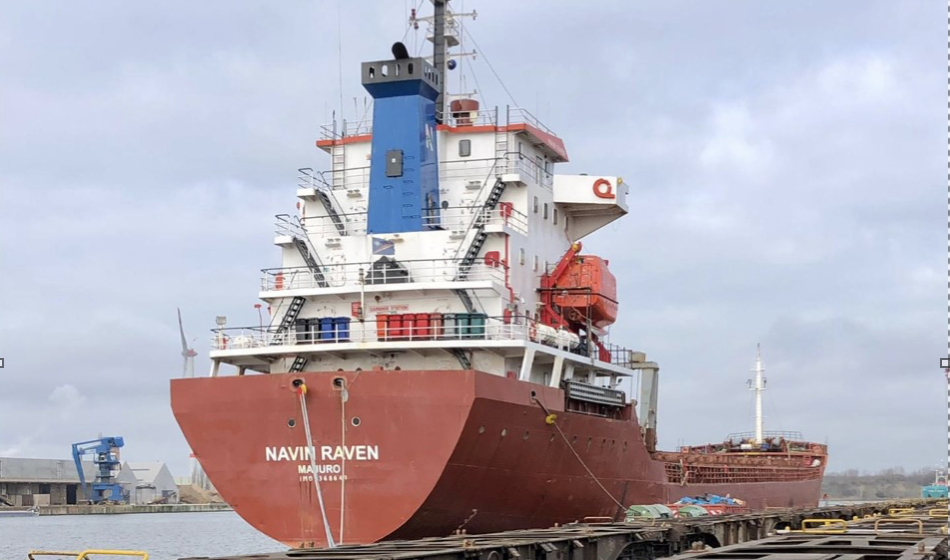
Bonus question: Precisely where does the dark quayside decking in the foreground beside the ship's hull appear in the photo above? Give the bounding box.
[182,500,948,560]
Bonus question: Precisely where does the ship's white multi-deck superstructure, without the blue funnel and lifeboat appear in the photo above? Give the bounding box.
[211,2,657,436]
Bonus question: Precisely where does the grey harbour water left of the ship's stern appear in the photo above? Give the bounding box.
[0,511,287,560]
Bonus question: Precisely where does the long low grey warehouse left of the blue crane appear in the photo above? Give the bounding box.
[0,457,96,507]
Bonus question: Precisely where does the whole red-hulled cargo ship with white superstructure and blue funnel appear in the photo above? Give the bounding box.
[171,0,827,547]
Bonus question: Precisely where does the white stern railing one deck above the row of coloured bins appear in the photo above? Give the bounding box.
[261,259,505,291]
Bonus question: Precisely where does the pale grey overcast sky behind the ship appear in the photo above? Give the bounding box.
[0,0,947,482]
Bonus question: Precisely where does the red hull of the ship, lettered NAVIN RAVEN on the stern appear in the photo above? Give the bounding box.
[171,370,824,547]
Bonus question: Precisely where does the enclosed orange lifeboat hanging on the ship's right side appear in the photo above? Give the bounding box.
[554,255,618,329]
